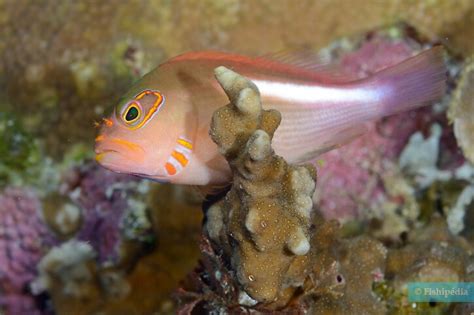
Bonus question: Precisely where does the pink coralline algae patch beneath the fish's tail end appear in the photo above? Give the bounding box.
[317,110,423,219]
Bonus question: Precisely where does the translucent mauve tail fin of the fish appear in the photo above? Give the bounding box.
[371,46,446,116]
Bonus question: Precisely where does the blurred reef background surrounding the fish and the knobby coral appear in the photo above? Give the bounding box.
[0,0,474,315]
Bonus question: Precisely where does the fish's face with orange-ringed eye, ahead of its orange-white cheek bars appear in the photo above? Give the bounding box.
[95,87,180,181]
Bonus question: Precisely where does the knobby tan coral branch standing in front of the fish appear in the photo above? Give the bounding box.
[205,67,316,302]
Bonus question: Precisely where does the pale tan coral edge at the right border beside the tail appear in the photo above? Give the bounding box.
[448,56,474,163]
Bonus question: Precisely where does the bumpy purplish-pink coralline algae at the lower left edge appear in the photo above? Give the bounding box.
[0,188,54,315]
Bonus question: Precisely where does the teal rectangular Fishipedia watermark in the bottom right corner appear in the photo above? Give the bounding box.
[408,282,474,303]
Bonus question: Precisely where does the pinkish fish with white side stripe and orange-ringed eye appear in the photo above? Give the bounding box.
[95,46,446,186]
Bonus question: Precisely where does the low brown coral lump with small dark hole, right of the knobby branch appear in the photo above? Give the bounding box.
[301,221,387,315]
